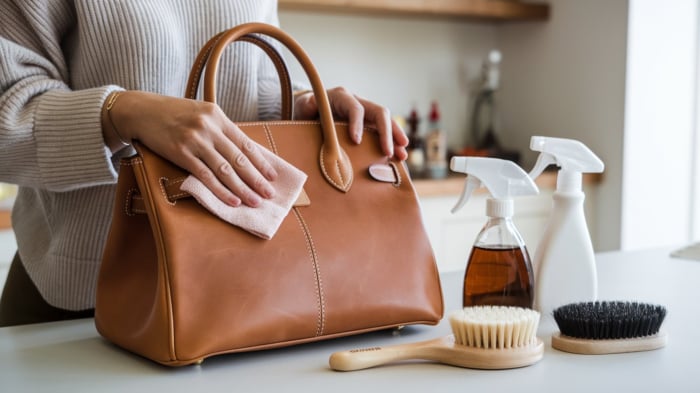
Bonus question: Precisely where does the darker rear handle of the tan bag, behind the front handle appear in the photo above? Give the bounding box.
[185,32,294,120]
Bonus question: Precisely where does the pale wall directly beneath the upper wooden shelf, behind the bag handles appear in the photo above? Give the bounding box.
[280,11,496,147]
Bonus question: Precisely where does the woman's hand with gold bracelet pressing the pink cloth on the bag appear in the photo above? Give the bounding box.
[102,91,277,207]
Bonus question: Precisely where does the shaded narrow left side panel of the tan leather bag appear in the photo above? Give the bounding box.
[95,158,170,362]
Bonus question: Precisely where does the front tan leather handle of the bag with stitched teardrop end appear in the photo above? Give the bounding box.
[191,23,353,192]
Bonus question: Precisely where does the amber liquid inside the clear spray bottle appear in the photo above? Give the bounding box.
[463,247,534,308]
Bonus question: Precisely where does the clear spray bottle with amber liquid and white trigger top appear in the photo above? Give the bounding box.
[450,157,539,308]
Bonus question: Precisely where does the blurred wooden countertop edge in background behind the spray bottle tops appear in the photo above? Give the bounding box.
[413,171,603,197]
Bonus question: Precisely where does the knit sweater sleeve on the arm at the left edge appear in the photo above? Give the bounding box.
[0,0,118,191]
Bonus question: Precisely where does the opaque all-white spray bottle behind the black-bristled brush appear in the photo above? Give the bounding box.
[530,136,604,316]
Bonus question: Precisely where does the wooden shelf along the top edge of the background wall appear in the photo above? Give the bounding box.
[279,0,549,22]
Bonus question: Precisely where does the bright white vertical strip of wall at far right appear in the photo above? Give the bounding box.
[621,0,699,249]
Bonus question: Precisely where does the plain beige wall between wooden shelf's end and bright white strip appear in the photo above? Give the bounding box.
[497,0,627,250]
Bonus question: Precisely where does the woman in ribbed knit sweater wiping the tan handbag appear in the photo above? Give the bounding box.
[0,0,408,326]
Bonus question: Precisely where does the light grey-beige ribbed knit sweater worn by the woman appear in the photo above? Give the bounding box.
[0,0,279,310]
